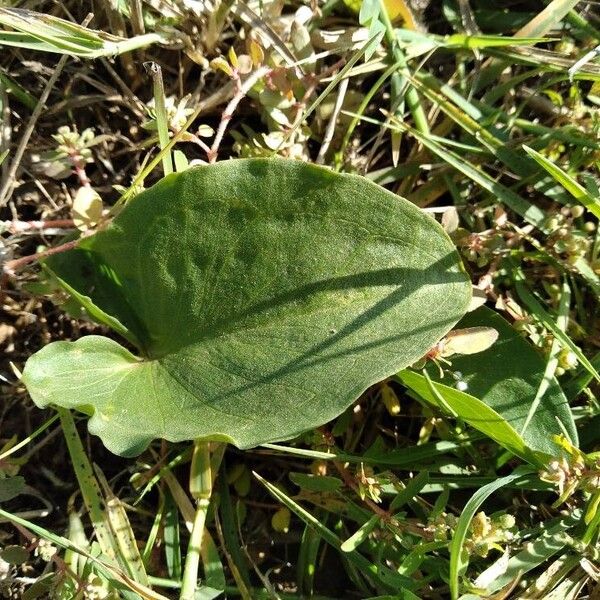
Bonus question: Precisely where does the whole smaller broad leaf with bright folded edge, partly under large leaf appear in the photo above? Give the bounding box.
[399,300,577,464]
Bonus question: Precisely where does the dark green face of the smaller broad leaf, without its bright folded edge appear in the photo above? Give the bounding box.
[430,306,577,456]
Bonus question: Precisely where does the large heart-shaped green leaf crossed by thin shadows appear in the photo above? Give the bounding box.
[23,159,470,454]
